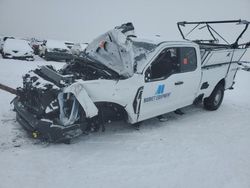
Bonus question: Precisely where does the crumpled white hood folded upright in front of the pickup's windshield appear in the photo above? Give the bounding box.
[86,23,134,77]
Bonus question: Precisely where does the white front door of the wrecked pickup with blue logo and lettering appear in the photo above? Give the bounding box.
[138,48,183,121]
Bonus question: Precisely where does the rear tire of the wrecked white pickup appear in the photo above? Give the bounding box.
[203,84,225,111]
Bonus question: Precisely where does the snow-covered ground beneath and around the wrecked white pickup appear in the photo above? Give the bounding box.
[0,58,250,188]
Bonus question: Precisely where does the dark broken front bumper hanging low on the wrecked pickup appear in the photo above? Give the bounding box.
[13,97,83,143]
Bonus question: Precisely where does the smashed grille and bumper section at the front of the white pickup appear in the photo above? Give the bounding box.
[13,66,82,142]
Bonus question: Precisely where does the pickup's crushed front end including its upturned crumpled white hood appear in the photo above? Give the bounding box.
[14,23,139,142]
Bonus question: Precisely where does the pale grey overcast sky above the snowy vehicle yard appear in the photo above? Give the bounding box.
[0,0,250,58]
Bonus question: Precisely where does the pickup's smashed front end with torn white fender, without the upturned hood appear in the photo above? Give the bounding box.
[13,62,109,142]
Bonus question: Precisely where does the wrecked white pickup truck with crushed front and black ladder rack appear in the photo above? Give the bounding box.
[13,20,249,142]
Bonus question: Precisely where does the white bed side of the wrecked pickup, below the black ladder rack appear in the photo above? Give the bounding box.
[198,48,246,97]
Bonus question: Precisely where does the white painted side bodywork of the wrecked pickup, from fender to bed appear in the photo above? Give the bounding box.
[69,42,244,123]
